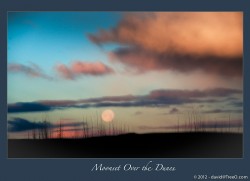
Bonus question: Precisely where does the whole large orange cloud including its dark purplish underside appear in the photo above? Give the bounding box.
[88,12,243,77]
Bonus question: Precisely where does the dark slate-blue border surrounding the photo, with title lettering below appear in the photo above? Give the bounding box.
[0,0,250,181]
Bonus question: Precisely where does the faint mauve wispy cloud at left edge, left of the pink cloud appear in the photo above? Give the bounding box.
[8,63,52,79]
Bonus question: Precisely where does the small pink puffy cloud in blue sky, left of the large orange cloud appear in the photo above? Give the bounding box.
[55,61,114,80]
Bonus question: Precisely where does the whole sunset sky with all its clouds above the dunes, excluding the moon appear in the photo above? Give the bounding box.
[7,12,243,138]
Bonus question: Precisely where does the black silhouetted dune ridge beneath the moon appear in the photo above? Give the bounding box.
[8,132,243,158]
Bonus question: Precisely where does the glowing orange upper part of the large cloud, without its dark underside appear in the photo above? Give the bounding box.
[90,12,243,57]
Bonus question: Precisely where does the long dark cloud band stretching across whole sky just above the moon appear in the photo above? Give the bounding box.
[8,88,242,113]
